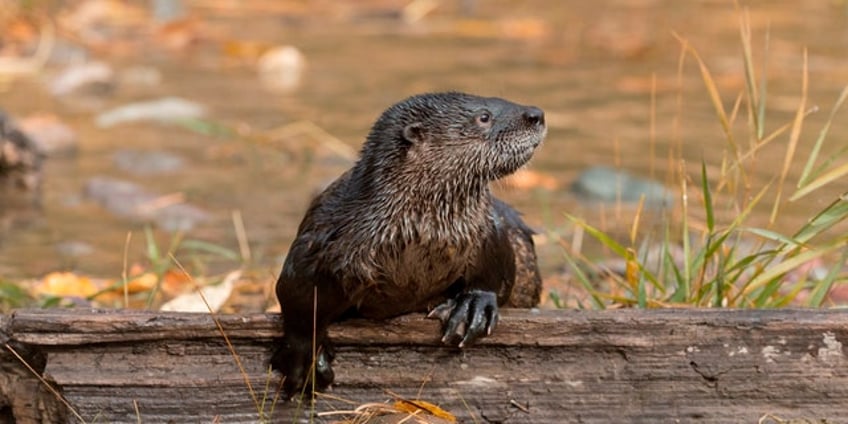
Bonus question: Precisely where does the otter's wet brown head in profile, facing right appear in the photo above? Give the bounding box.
[362,92,547,184]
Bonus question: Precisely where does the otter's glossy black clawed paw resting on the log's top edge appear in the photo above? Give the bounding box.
[427,290,498,347]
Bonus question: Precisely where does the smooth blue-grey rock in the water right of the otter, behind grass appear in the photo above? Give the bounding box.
[571,166,674,207]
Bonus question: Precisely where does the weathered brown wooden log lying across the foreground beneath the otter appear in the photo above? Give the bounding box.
[0,309,848,423]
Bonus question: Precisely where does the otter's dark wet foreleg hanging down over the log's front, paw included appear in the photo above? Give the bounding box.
[271,273,350,398]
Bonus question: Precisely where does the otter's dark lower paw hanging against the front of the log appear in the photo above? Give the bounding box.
[271,335,335,399]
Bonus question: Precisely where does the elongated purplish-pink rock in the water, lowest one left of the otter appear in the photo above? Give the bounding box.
[85,177,210,232]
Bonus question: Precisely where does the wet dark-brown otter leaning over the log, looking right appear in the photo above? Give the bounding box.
[271,92,546,395]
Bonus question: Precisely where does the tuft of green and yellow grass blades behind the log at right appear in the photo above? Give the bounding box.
[552,11,848,309]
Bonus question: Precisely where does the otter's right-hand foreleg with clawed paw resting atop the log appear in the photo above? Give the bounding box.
[427,225,515,348]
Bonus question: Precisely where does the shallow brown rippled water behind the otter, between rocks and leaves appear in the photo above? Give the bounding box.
[0,0,848,278]
